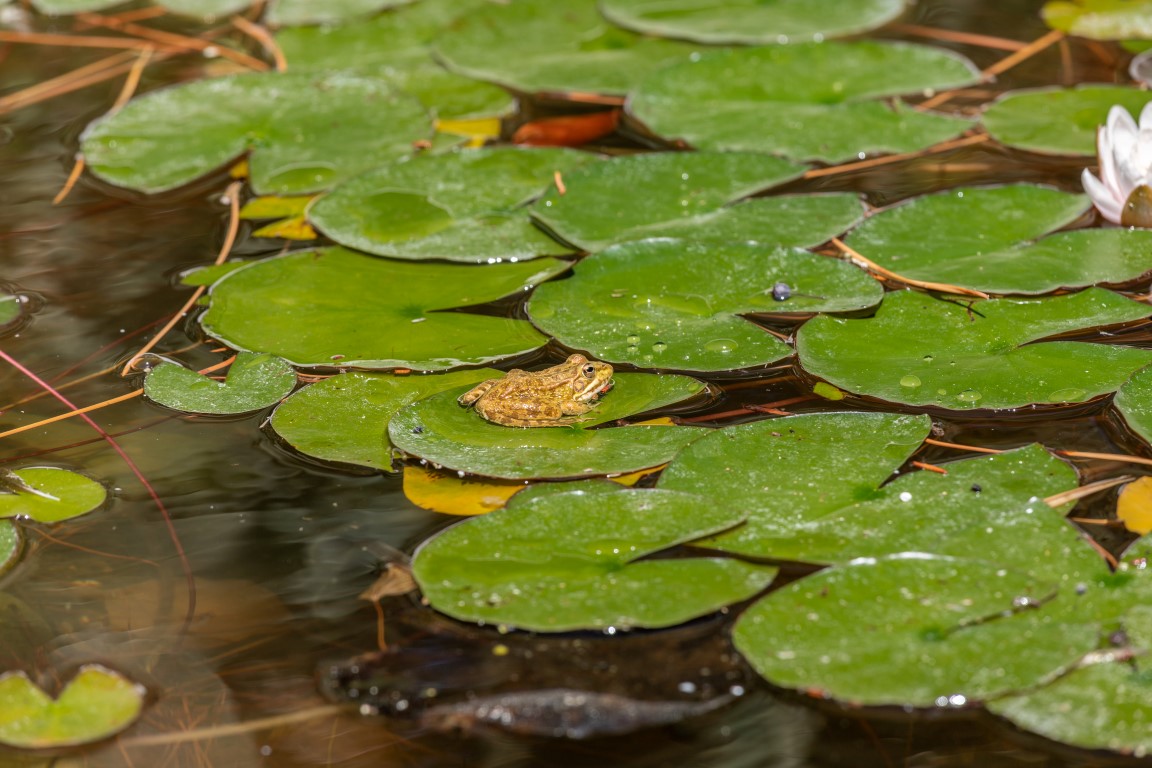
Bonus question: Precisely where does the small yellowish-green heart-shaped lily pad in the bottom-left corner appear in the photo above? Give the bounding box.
[0,664,147,750]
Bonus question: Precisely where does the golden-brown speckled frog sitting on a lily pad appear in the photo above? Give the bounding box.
[456,355,612,427]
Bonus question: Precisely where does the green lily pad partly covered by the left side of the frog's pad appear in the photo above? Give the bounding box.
[272,368,500,472]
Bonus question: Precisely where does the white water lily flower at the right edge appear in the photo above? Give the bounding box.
[1081,101,1152,227]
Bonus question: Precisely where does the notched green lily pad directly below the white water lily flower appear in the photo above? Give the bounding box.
[848,184,1152,294]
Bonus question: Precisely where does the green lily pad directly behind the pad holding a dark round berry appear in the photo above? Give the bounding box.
[532,152,811,251]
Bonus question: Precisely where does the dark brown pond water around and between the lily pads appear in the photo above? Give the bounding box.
[0,0,1139,768]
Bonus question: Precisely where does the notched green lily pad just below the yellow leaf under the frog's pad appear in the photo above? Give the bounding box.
[412,489,776,632]
